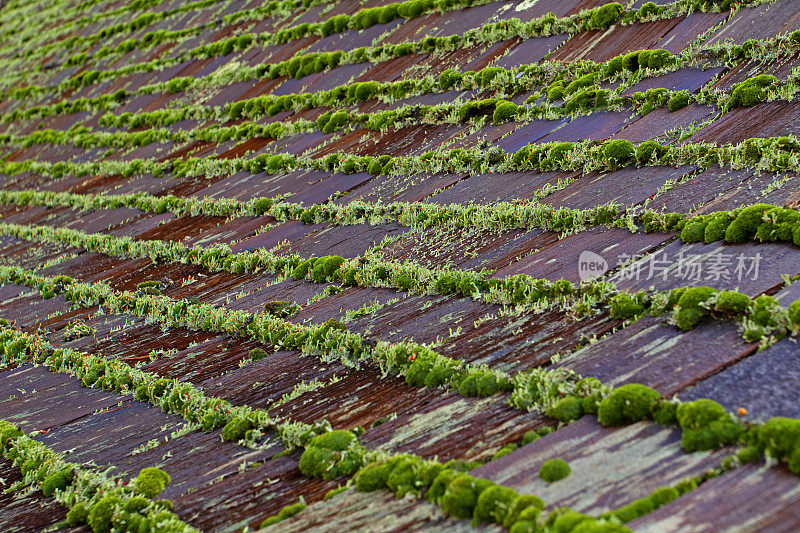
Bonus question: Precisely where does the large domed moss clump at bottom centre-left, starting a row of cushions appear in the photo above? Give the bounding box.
[300,430,363,480]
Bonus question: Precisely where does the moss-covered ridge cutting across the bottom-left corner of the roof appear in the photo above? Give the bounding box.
[0,420,199,533]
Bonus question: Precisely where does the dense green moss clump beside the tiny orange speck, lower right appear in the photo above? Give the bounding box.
[677,399,744,452]
